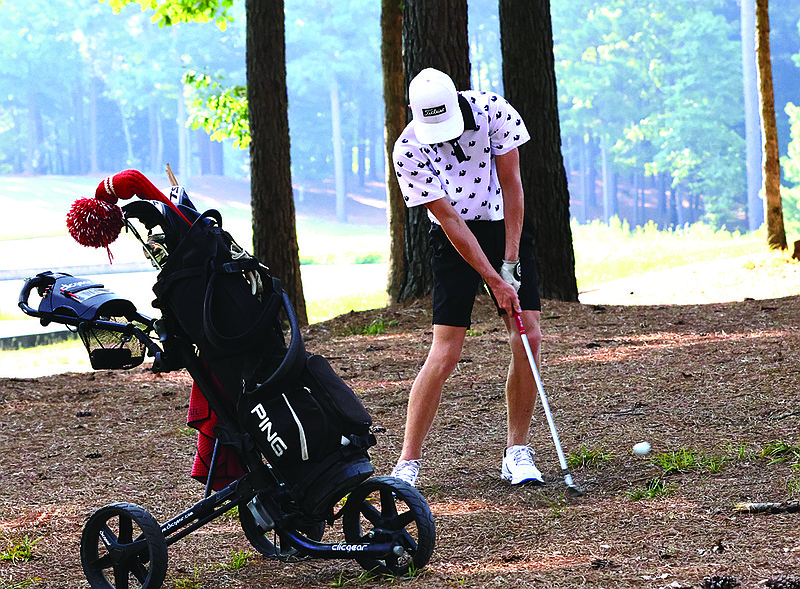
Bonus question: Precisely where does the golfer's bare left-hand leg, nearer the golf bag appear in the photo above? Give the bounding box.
[400,325,467,460]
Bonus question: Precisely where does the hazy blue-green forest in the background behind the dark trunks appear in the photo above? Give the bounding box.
[0,0,800,233]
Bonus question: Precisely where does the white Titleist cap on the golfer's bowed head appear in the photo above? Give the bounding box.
[408,68,464,144]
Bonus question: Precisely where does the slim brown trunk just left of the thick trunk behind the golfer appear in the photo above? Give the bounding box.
[381,0,406,302]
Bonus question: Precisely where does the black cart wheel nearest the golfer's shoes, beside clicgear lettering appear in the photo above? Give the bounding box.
[342,477,436,577]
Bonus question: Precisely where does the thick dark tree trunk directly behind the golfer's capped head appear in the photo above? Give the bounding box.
[397,0,470,301]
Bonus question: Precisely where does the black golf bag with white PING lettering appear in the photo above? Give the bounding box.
[142,189,375,519]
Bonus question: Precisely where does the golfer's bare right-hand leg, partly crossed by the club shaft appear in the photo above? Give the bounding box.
[503,311,542,447]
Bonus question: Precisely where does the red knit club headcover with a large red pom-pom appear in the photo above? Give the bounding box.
[67,170,191,261]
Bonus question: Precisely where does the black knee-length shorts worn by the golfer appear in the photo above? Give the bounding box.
[430,221,542,327]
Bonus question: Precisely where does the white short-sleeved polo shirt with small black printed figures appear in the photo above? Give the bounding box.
[392,90,530,223]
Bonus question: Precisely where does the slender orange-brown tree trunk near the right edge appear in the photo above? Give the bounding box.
[756,0,786,250]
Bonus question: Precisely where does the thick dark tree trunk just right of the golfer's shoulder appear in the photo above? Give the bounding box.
[500,0,578,301]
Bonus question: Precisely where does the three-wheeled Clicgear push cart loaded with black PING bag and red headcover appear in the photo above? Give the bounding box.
[19,170,435,589]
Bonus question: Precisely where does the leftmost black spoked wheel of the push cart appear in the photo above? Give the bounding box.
[81,503,167,589]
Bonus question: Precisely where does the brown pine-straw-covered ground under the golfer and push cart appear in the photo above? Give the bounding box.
[0,253,800,589]
